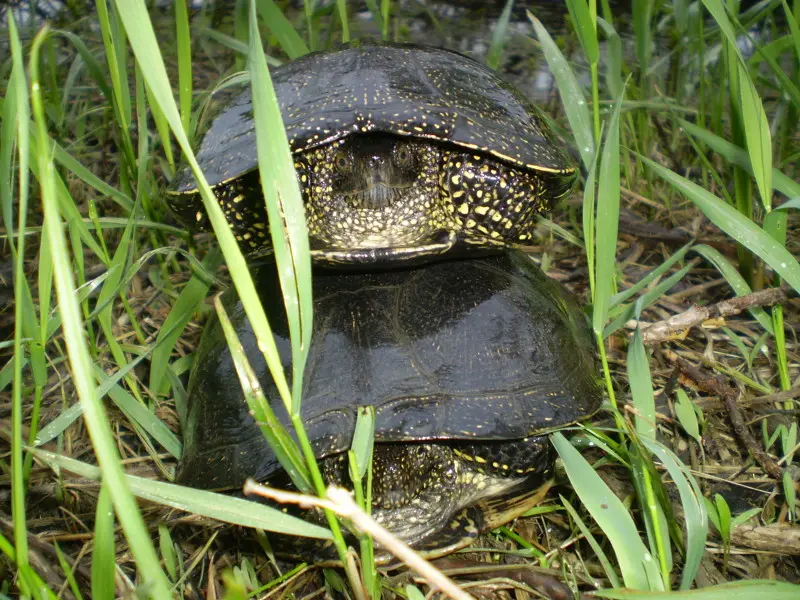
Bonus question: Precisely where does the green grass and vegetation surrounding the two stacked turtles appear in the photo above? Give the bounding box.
[0,0,800,599]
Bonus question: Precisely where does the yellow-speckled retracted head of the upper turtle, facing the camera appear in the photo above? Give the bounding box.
[295,134,455,264]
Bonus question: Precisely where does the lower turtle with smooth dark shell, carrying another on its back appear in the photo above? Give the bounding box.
[177,250,602,556]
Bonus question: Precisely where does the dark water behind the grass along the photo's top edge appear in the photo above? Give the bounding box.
[0,0,782,106]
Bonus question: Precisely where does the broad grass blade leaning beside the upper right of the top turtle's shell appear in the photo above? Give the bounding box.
[528,12,595,169]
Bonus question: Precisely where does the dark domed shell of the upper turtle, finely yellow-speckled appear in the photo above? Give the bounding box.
[172,42,575,194]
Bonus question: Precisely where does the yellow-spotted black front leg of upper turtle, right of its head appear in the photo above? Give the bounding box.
[439,152,568,246]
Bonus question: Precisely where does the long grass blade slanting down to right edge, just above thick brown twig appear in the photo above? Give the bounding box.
[639,155,800,291]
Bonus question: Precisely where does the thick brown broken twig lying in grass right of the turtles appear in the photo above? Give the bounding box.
[641,288,797,344]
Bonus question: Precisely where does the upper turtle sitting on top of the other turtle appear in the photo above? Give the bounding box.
[167,41,577,265]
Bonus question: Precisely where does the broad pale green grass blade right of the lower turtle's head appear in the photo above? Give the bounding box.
[551,432,661,590]
